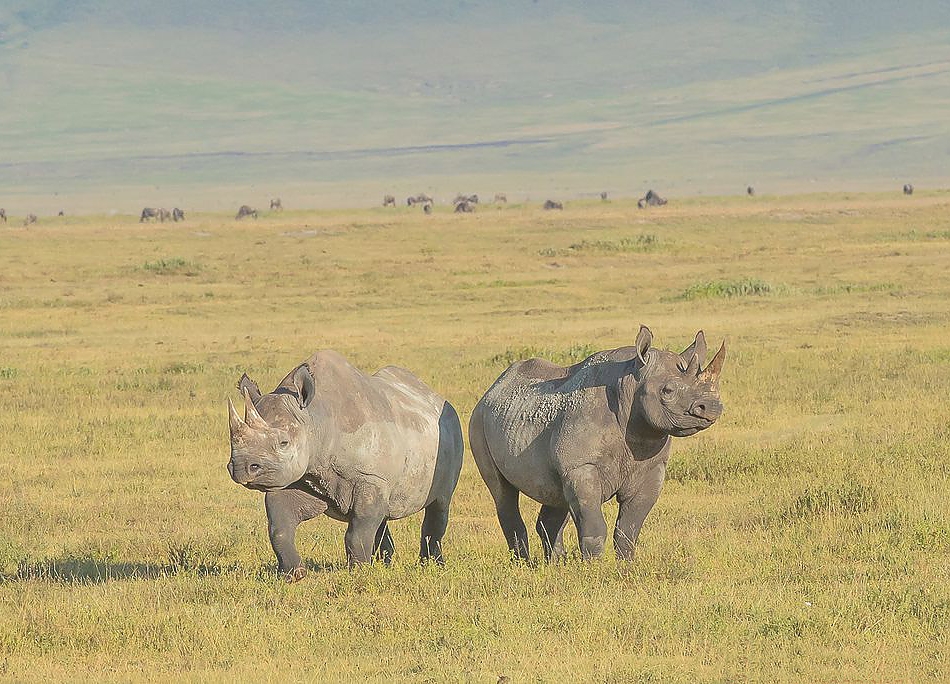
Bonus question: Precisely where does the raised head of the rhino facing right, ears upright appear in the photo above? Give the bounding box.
[633,326,726,437]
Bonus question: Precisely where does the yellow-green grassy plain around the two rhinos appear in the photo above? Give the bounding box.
[0,193,950,682]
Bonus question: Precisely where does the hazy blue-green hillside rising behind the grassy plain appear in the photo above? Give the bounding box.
[0,0,950,213]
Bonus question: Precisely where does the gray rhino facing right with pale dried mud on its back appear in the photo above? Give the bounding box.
[469,327,726,560]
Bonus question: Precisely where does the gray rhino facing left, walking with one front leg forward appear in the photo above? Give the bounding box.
[228,351,462,582]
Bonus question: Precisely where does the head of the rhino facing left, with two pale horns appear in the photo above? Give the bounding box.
[228,365,315,492]
